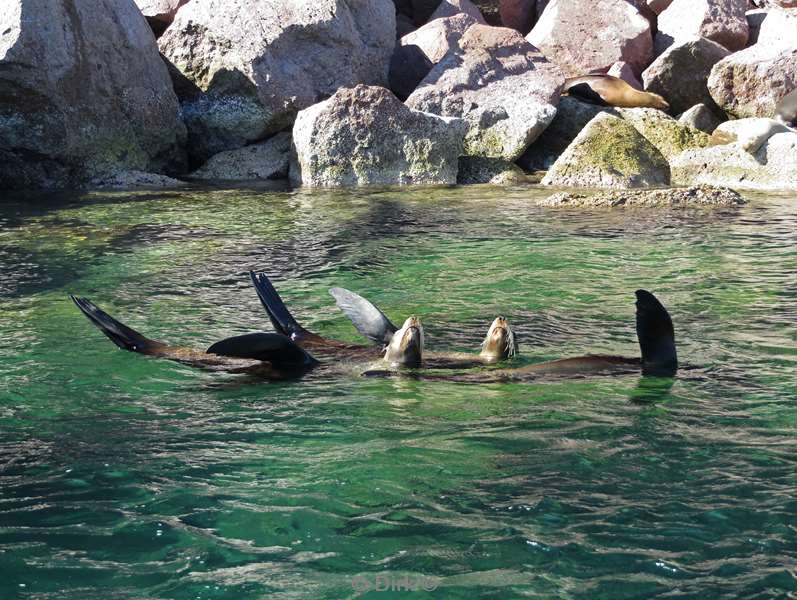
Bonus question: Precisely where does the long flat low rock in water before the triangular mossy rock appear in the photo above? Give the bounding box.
[537,185,747,208]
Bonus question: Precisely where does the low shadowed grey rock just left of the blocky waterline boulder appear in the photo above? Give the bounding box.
[191,132,291,181]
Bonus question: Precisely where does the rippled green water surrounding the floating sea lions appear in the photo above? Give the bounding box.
[0,187,797,600]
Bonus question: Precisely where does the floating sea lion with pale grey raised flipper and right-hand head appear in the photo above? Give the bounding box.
[249,272,517,369]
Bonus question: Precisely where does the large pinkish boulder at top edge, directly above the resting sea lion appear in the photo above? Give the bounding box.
[526,0,653,77]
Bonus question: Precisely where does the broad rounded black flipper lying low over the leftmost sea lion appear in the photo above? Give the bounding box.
[207,333,318,369]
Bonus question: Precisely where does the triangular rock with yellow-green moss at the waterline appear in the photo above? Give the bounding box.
[542,112,670,188]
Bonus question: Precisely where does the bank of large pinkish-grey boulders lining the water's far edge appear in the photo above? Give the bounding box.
[0,0,797,192]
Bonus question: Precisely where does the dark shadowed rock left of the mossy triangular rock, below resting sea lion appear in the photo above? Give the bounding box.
[517,96,619,171]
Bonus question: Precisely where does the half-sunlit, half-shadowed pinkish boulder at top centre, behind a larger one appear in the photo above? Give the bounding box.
[389,13,476,100]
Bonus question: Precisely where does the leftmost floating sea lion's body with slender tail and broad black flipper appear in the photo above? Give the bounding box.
[70,296,319,380]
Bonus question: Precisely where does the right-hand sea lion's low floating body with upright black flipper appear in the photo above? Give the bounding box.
[363,290,678,383]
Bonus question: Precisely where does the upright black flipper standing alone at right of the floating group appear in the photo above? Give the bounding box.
[636,290,678,376]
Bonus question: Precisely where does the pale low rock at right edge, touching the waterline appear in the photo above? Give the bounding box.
[670,132,797,190]
